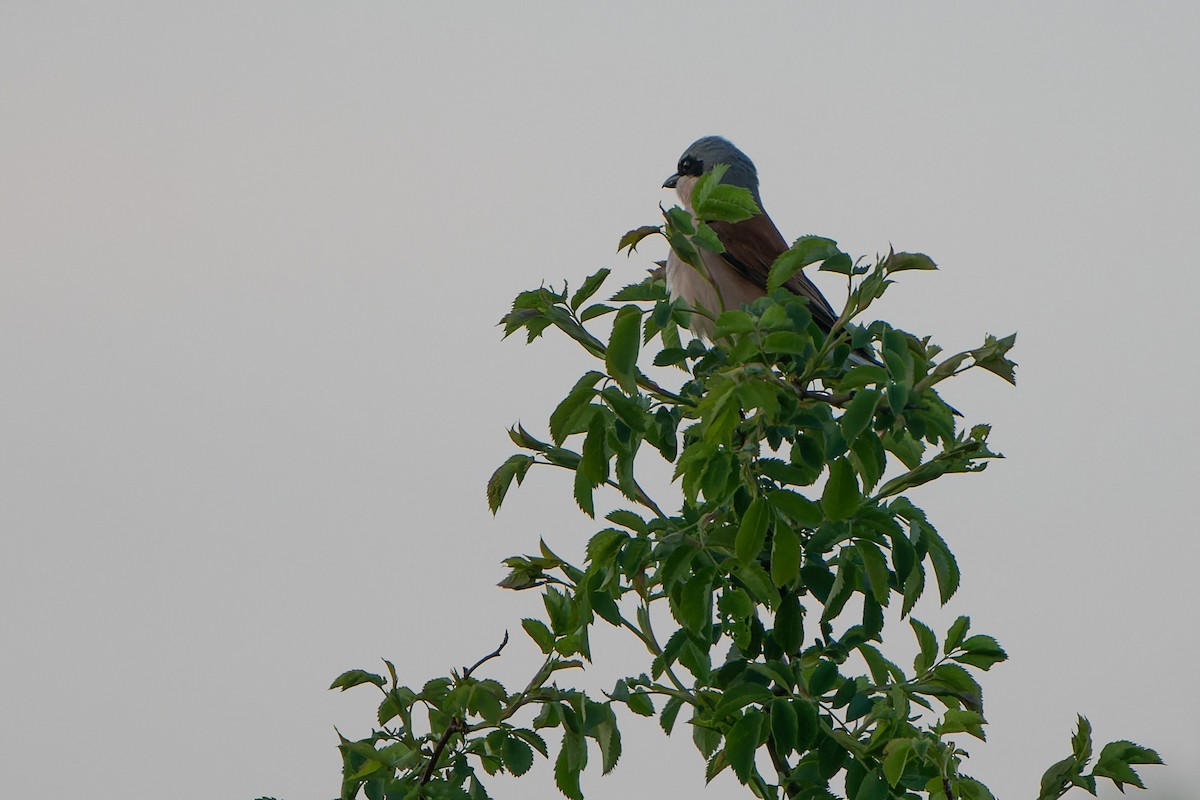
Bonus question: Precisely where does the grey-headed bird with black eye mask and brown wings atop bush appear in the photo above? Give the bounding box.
[662,136,838,339]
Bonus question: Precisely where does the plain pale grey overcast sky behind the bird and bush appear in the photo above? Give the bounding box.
[0,2,1200,800]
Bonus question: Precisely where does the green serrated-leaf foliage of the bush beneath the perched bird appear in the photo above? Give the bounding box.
[324,208,1159,800]
